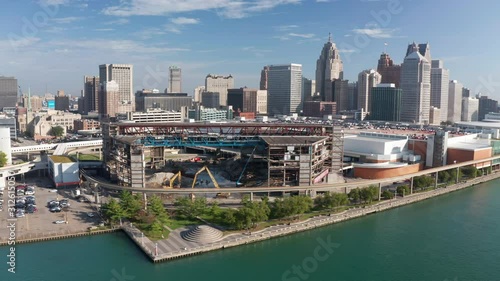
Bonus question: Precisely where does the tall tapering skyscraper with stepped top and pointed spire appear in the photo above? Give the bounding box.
[316,35,344,101]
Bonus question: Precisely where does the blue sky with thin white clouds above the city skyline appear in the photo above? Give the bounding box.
[0,0,500,99]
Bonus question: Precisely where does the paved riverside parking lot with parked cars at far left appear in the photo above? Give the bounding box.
[0,178,105,240]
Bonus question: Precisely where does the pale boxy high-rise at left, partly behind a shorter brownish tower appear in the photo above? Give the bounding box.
[99,64,135,113]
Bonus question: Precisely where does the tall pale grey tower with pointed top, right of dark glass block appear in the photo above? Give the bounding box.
[401,48,431,124]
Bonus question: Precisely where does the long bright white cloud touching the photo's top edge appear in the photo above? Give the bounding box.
[103,0,302,18]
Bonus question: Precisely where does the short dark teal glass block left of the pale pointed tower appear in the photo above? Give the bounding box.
[370,84,403,122]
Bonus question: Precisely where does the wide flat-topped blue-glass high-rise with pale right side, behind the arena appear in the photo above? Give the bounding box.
[267,63,302,115]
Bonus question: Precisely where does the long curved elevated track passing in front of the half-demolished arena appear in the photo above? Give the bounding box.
[81,155,500,194]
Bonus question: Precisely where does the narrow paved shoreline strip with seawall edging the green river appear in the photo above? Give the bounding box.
[121,172,500,263]
